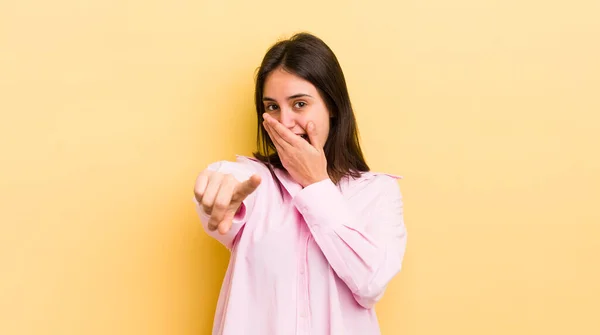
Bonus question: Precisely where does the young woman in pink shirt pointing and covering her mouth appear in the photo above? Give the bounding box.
[194,33,406,335]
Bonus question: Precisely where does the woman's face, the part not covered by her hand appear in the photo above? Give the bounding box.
[263,68,330,149]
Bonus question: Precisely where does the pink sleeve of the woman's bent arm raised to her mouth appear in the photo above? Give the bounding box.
[294,175,406,308]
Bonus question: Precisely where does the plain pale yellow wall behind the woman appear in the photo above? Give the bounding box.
[0,0,600,335]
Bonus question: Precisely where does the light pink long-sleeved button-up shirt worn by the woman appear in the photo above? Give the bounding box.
[196,156,406,335]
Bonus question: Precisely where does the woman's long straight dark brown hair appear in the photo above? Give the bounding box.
[254,33,369,184]
